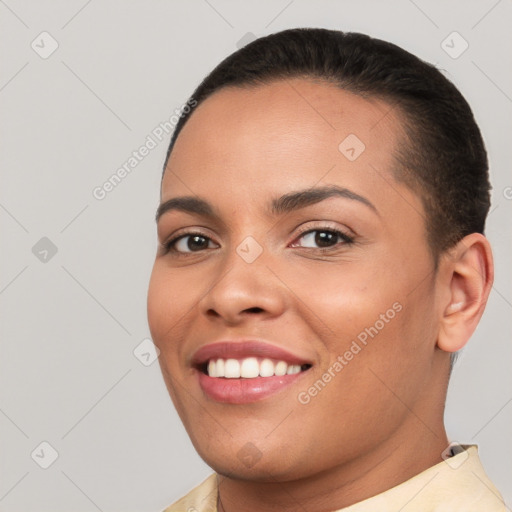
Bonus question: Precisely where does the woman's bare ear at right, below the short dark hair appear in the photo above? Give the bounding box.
[437,233,494,352]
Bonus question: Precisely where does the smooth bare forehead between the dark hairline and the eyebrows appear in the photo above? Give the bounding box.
[162,79,414,216]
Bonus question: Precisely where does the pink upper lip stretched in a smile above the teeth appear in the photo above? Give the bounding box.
[192,340,312,367]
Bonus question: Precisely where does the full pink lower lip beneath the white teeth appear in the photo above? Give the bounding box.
[197,371,305,404]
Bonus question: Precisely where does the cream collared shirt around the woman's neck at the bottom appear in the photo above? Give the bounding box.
[163,445,508,512]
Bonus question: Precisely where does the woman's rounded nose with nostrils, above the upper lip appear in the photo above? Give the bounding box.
[199,250,286,325]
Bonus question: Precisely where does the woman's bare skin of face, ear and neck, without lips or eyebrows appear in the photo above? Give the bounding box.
[148,79,493,512]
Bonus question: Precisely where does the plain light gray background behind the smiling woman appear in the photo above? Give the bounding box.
[0,0,512,512]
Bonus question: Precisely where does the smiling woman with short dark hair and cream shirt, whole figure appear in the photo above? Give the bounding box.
[148,29,505,512]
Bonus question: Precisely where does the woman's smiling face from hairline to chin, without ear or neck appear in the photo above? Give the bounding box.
[148,79,444,481]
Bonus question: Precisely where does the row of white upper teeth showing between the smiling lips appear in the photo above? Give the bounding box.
[207,357,301,379]
